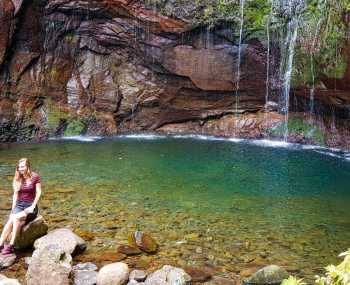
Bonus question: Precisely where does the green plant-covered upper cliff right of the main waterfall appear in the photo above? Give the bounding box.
[294,0,350,84]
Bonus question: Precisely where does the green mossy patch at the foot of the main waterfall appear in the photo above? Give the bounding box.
[268,118,325,144]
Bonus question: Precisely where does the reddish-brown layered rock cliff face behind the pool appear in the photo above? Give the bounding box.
[0,0,350,146]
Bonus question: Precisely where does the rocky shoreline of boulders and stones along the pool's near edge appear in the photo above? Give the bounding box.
[0,216,300,285]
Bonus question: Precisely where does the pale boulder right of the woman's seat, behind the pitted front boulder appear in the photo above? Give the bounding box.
[34,228,86,256]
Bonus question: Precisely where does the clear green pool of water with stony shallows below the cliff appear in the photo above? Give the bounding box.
[0,138,350,279]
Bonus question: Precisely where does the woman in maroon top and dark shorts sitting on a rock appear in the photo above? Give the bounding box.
[0,158,41,255]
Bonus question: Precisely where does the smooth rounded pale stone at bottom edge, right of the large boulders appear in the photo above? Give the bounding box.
[97,262,129,285]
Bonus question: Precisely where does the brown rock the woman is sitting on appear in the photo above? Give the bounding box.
[15,215,49,249]
